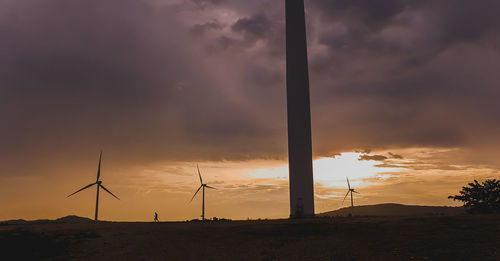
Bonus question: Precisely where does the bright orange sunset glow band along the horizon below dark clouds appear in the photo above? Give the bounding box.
[0,148,497,221]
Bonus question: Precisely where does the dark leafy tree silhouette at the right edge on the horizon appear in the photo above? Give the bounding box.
[448,179,500,213]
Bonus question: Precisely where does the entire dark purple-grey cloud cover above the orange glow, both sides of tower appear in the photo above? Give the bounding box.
[0,0,500,178]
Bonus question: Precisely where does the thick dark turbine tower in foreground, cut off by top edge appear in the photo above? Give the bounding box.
[285,0,314,218]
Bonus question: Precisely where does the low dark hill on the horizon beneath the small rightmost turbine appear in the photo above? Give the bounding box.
[318,203,465,217]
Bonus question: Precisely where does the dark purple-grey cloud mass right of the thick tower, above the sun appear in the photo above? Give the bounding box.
[308,1,500,160]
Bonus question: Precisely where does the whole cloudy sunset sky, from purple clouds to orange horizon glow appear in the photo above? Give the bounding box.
[0,0,500,221]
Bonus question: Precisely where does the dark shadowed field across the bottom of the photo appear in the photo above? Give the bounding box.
[0,215,500,260]
